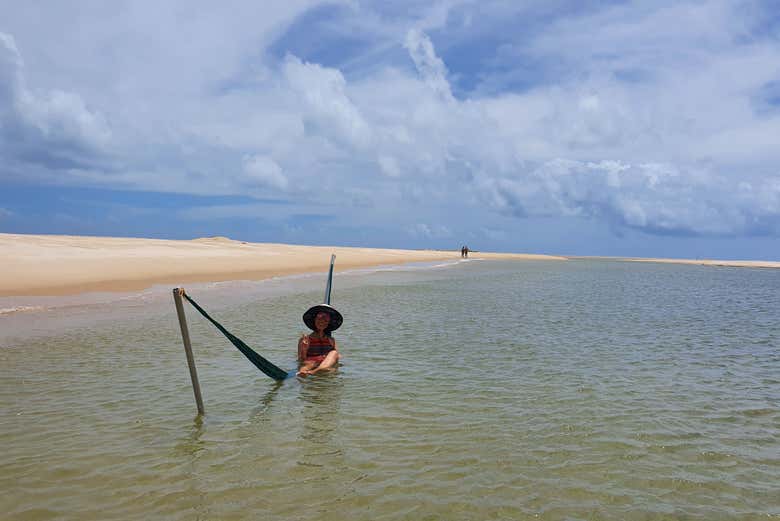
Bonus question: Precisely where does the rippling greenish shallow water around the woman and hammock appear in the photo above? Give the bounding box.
[0,260,780,520]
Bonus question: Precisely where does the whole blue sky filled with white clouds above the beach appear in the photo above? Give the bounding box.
[0,0,780,260]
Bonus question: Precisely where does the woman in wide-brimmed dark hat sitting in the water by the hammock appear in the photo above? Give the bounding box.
[298,304,344,376]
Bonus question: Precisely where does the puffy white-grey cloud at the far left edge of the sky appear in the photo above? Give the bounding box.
[0,33,111,169]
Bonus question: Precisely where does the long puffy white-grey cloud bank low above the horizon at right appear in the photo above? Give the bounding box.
[482,160,778,235]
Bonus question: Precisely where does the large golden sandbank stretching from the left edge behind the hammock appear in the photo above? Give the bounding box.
[0,234,565,297]
